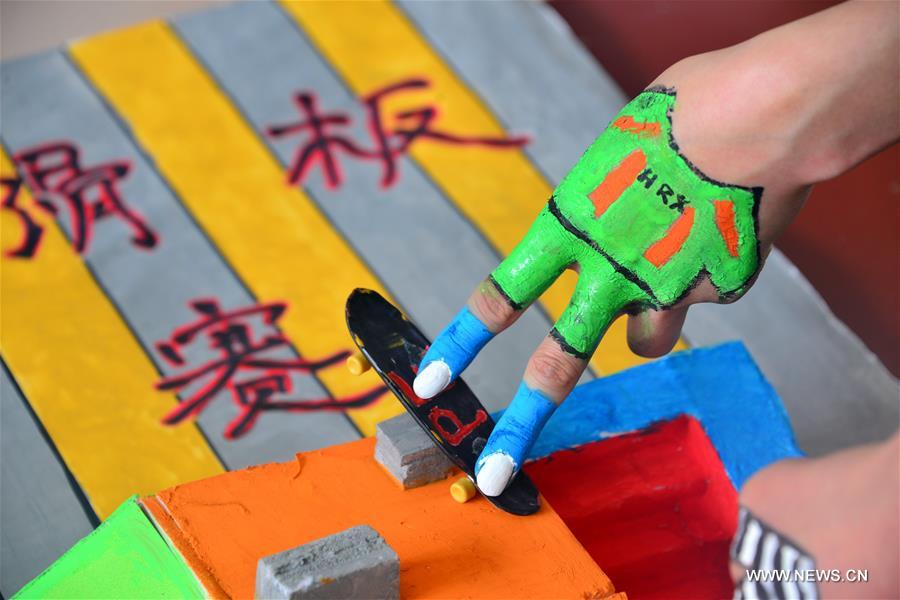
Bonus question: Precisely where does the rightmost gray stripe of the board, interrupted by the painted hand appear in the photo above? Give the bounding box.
[401,0,900,454]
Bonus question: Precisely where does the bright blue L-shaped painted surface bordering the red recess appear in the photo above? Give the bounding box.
[502,342,803,490]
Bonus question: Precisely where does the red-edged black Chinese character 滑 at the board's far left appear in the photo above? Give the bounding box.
[11,142,158,256]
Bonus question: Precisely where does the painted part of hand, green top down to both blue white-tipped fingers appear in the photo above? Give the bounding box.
[415,88,762,495]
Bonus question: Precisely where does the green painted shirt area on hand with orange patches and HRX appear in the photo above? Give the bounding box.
[491,89,762,358]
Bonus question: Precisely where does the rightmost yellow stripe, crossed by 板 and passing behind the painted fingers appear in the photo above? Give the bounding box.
[282,0,685,373]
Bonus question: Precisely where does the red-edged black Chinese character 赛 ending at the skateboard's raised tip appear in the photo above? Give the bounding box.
[156,299,387,439]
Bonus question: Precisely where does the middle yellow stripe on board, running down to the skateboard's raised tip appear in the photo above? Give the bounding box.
[70,22,402,435]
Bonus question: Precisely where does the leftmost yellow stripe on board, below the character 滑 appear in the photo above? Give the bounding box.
[0,151,223,519]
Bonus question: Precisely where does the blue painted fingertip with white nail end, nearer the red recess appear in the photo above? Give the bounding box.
[475,381,556,496]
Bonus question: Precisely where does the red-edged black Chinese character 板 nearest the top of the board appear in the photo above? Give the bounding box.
[266,78,528,189]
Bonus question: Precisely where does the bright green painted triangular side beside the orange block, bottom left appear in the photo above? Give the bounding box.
[14,496,205,599]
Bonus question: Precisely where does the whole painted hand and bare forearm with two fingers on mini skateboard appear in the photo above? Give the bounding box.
[426,2,900,495]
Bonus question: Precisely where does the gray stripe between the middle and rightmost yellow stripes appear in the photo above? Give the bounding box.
[174,3,550,410]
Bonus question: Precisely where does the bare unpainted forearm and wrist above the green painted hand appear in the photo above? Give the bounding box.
[655,2,900,195]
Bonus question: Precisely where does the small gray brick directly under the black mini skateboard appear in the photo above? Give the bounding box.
[375,413,453,489]
